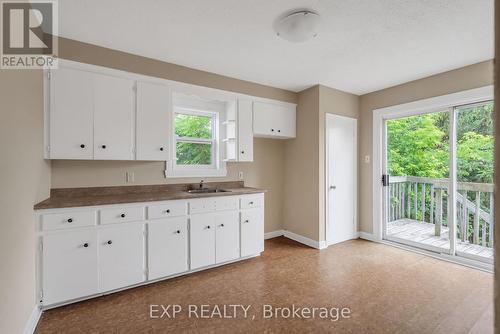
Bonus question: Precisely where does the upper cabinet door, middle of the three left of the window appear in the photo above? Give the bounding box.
[94,74,135,160]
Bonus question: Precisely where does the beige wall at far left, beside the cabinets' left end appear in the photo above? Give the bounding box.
[0,70,50,333]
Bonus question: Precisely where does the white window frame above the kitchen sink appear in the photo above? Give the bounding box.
[165,91,227,178]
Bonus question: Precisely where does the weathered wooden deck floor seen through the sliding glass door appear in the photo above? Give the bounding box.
[386,218,493,263]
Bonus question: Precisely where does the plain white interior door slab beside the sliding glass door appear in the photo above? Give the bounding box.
[326,114,357,245]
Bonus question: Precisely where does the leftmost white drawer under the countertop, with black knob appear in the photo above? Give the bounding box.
[42,211,96,231]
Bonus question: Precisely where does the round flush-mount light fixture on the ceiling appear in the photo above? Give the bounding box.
[274,10,320,43]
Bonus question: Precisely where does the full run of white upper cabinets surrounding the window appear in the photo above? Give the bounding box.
[44,60,296,161]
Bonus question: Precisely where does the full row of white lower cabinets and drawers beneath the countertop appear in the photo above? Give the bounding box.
[37,194,264,306]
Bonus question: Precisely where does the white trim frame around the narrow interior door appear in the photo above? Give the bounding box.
[324,113,359,247]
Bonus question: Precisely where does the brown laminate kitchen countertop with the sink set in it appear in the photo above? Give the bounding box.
[34,182,267,210]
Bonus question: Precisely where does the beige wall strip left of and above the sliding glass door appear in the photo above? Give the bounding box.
[358,61,493,233]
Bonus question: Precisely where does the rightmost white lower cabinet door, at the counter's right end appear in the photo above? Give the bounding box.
[241,208,264,257]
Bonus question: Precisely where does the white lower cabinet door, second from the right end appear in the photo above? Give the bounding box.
[215,211,240,263]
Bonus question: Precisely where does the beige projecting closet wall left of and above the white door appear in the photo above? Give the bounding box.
[284,85,359,241]
